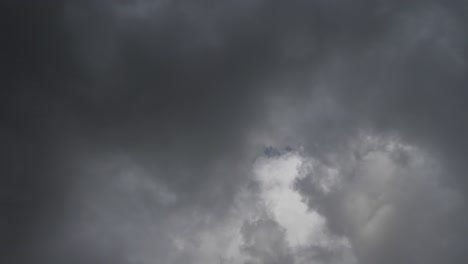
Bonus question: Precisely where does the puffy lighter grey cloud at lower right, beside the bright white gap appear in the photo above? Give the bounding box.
[297,135,466,263]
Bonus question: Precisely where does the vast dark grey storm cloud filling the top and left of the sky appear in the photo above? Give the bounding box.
[0,0,468,263]
